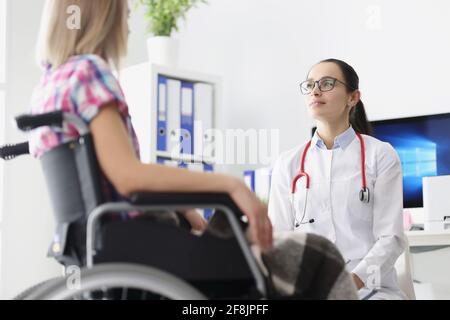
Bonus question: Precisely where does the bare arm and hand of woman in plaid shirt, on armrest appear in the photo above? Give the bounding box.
[90,103,272,250]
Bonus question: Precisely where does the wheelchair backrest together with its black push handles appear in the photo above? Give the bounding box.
[5,110,104,266]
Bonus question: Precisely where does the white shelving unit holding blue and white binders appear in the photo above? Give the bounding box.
[119,63,222,219]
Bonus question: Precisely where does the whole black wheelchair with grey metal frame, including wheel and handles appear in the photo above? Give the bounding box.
[0,111,271,300]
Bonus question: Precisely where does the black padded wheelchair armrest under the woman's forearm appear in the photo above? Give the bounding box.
[130,192,244,218]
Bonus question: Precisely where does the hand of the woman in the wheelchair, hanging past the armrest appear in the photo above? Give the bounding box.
[230,180,272,252]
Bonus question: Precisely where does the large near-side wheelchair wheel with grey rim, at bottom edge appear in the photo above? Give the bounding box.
[25,263,206,300]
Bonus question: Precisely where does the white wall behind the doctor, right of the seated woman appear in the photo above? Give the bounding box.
[128,0,450,172]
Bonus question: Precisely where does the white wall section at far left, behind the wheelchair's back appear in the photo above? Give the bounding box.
[0,0,60,298]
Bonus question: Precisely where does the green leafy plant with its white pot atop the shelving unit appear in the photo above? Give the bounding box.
[138,0,207,66]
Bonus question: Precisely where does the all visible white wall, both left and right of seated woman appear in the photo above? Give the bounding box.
[0,0,450,297]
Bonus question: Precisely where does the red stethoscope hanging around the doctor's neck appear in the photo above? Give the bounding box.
[291,133,370,228]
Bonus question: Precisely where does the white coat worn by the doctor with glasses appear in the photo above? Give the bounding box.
[269,127,406,299]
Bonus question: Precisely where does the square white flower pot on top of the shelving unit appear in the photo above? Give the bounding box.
[147,36,178,67]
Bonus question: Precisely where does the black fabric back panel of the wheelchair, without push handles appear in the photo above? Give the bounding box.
[41,134,103,266]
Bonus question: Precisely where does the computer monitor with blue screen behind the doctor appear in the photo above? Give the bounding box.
[371,113,450,208]
